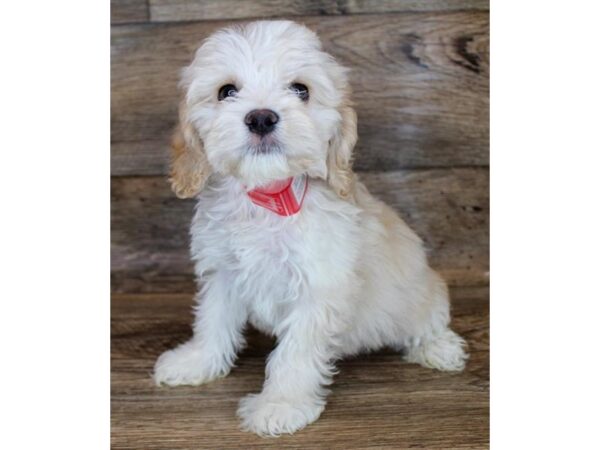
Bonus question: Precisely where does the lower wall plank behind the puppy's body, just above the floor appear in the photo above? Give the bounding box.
[111,168,489,292]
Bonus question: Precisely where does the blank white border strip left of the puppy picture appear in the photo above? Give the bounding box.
[0,1,110,450]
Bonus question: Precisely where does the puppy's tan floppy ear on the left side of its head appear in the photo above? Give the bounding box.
[169,100,212,198]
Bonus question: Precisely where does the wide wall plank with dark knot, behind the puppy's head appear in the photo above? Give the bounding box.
[111,11,489,175]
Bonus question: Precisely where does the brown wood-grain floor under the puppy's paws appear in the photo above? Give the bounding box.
[111,288,489,450]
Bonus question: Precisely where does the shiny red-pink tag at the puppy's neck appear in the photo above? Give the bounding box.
[248,175,308,216]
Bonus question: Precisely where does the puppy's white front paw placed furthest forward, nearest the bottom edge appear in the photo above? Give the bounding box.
[237,394,324,436]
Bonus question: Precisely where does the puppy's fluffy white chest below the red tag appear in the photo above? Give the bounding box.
[191,183,358,331]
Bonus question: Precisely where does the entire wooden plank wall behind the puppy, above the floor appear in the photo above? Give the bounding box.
[111,0,489,293]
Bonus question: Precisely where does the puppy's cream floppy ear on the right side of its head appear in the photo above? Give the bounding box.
[327,102,357,199]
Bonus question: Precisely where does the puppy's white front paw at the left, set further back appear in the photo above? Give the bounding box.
[154,343,229,386]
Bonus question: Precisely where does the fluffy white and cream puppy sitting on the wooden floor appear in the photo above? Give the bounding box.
[154,21,467,436]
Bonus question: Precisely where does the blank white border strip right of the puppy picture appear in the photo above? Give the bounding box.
[491,1,600,450]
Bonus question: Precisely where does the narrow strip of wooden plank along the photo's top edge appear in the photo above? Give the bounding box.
[150,0,489,22]
